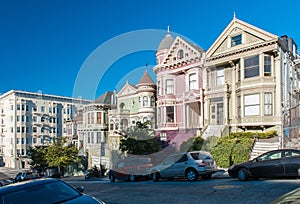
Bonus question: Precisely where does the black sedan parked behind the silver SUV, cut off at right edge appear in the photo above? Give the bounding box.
[228,149,300,181]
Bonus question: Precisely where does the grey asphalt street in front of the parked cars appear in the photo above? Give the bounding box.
[67,177,300,204]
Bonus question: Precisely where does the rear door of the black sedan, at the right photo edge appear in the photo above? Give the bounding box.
[282,150,300,176]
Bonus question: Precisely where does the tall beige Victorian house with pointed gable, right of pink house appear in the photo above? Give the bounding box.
[203,16,300,146]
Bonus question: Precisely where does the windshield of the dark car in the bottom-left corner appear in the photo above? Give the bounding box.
[2,181,81,204]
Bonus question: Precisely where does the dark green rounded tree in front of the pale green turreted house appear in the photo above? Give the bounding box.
[120,121,163,155]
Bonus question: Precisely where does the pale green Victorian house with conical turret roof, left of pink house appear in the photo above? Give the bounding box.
[108,70,156,151]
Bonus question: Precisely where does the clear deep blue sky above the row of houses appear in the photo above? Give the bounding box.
[0,0,300,99]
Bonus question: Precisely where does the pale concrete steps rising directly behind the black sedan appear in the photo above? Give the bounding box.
[250,141,280,160]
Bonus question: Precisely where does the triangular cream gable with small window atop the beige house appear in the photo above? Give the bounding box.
[206,16,278,58]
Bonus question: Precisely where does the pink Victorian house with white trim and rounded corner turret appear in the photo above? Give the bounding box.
[153,31,206,146]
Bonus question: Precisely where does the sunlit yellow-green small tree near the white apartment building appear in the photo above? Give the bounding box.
[45,138,80,175]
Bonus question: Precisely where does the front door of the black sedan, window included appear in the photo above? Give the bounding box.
[250,150,284,178]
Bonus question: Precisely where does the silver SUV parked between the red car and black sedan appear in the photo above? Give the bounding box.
[151,151,217,181]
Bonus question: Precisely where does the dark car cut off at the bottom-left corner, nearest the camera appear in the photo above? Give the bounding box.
[0,178,104,204]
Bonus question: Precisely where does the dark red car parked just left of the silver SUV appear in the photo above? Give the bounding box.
[108,156,152,182]
